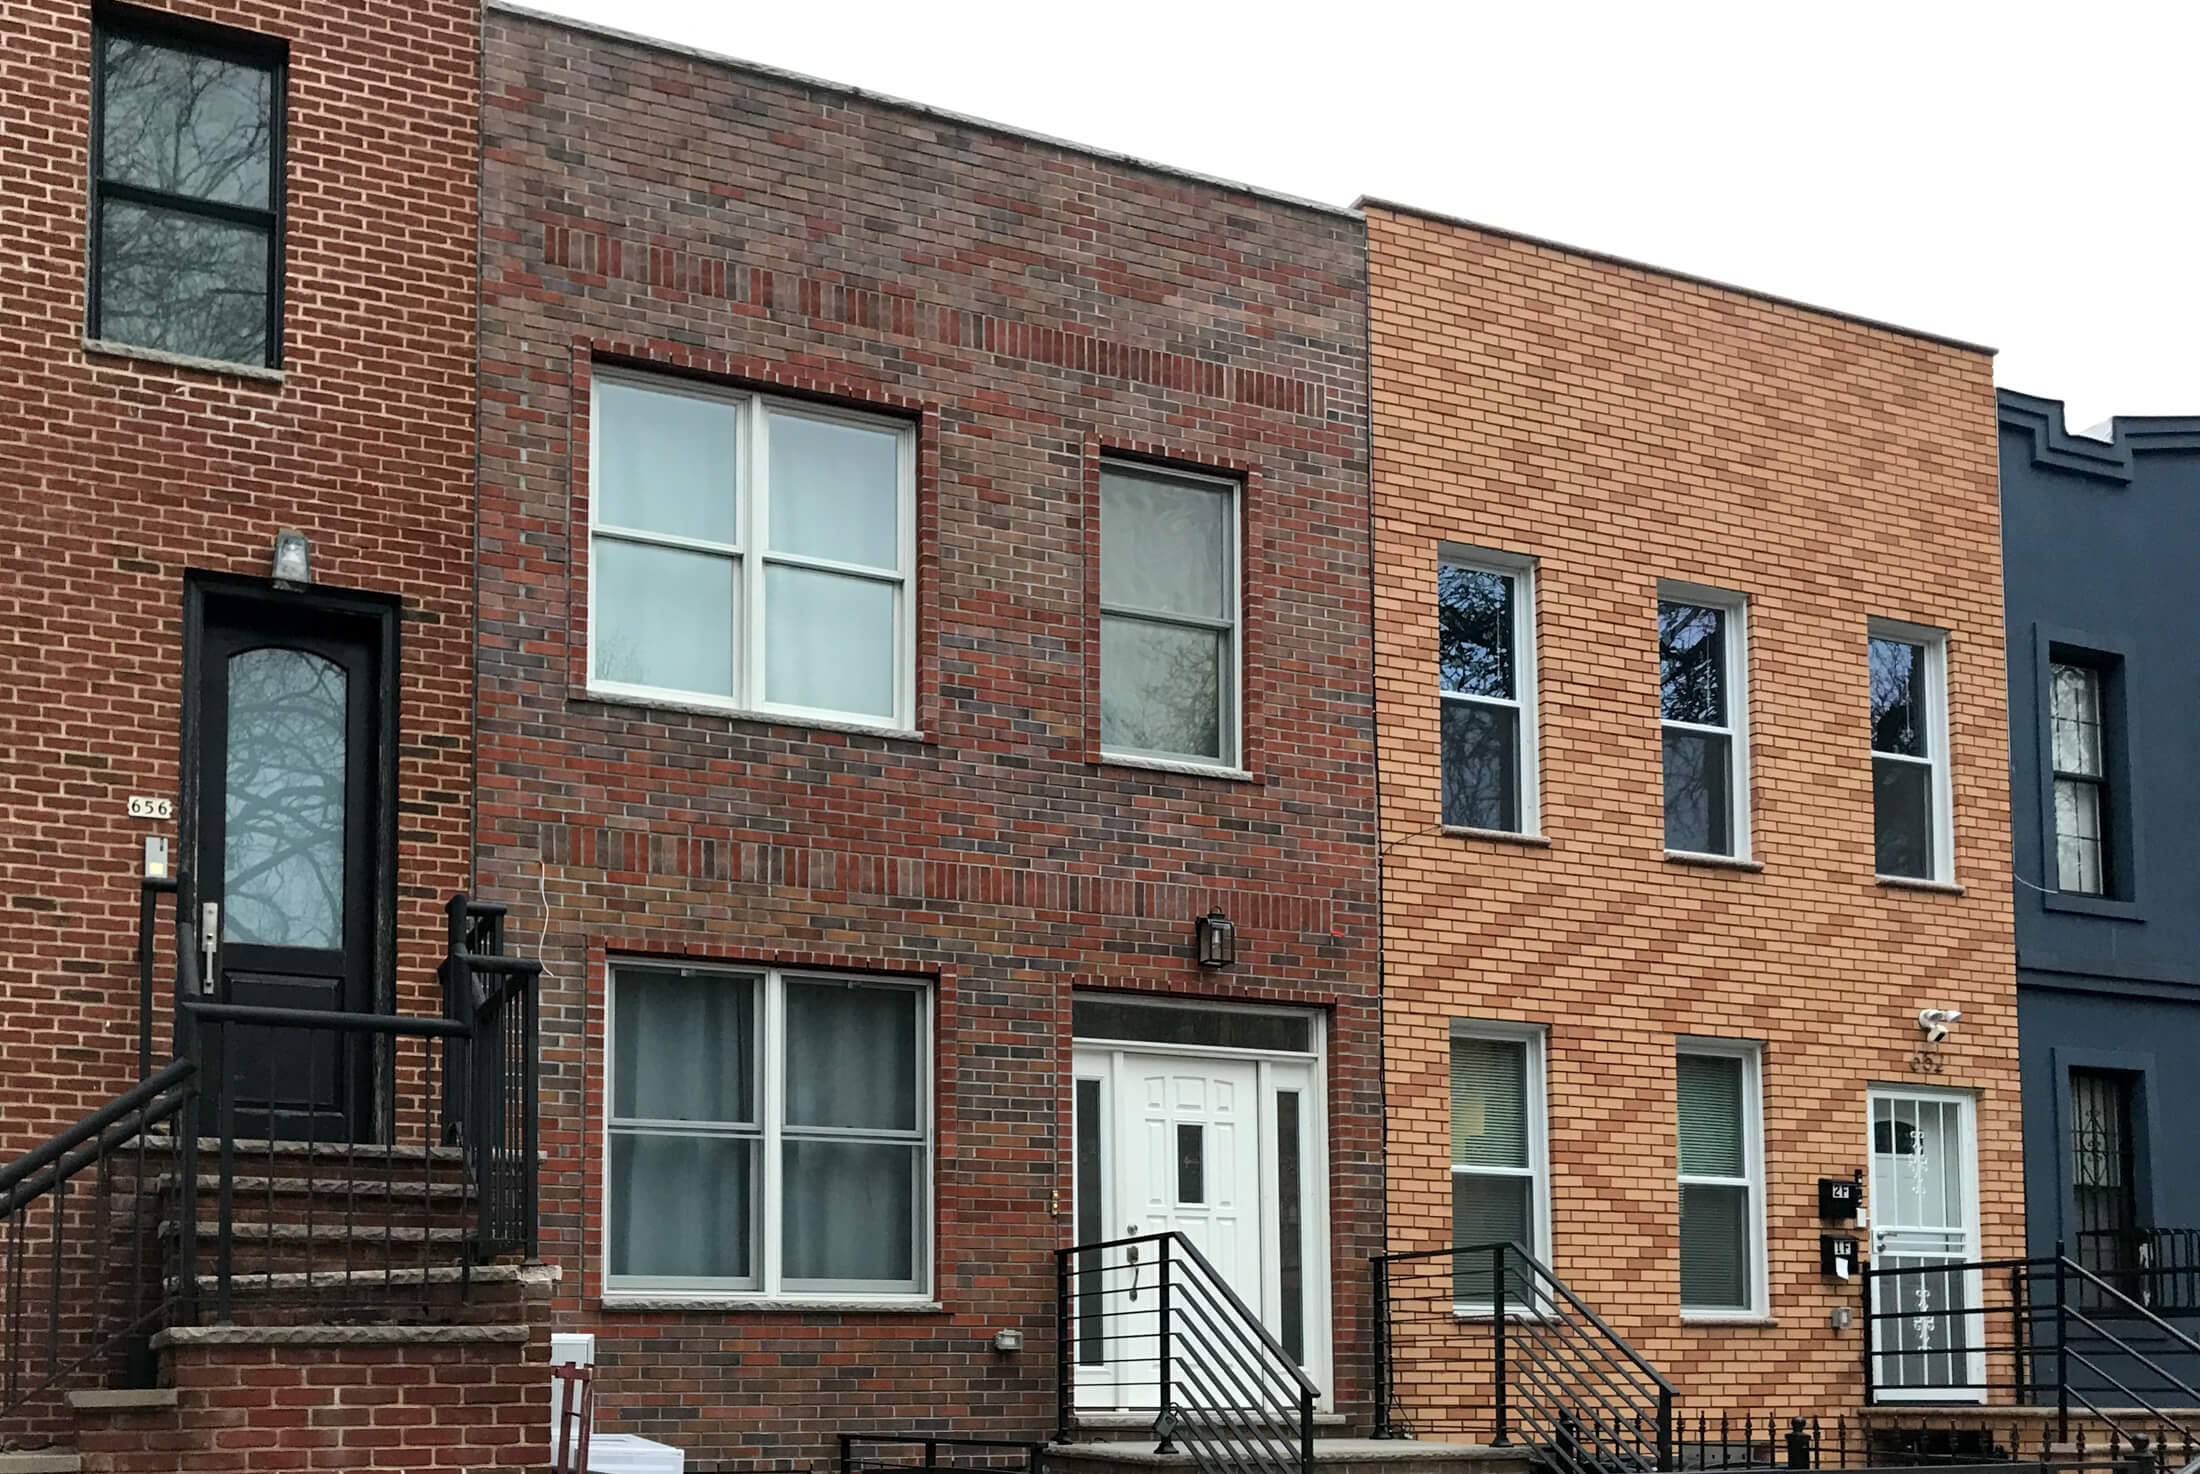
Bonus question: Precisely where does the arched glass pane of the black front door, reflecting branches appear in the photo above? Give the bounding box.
[222,649,348,946]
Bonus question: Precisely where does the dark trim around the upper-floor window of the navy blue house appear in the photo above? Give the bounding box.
[2033,625,2145,922]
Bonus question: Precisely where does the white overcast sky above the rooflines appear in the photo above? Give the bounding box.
[530,0,2200,429]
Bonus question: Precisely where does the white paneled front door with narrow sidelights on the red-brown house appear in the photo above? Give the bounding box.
[1071,1045,1327,1410]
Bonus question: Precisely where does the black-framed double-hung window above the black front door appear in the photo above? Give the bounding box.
[86,11,284,367]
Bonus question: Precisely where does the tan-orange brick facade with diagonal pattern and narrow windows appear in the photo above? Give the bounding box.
[1368,205,2024,1415]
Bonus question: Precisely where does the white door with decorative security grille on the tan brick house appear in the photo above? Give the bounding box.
[1868,1087,1987,1401]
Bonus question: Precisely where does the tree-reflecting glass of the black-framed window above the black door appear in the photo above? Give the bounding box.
[99,35,273,363]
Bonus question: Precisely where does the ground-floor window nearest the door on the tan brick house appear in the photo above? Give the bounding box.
[1676,1049,1762,1313]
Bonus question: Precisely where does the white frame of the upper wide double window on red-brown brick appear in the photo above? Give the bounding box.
[587,367,917,733]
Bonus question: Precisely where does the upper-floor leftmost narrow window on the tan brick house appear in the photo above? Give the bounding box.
[1437,548,1538,834]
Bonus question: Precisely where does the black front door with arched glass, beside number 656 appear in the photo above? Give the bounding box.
[187,590,394,1142]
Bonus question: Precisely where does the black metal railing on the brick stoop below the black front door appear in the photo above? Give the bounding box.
[0,878,541,1415]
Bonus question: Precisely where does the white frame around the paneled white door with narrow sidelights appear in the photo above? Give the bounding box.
[1069,1016,1333,1412]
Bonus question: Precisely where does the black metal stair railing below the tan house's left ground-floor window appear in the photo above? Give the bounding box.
[1373,1243,1676,1474]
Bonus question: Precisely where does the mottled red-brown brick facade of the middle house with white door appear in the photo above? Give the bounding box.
[477,9,1379,1467]
